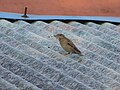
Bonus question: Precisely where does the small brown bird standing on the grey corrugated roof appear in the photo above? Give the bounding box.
[54,34,83,56]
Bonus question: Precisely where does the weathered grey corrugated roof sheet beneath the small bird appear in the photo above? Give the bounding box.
[0,19,120,90]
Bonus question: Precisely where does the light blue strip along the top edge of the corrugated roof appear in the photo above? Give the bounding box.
[0,12,120,23]
